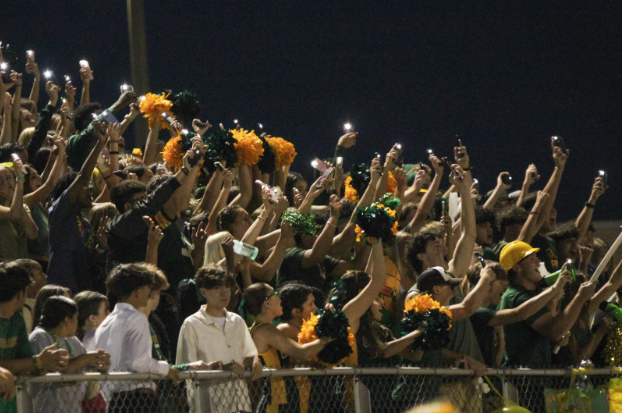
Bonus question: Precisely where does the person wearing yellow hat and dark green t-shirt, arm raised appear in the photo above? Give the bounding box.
[499,241,595,368]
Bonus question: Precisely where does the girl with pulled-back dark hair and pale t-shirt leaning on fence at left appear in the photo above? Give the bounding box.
[28,296,110,413]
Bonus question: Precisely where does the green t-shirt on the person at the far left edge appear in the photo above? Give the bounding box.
[0,311,33,413]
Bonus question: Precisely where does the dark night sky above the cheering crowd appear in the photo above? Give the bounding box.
[0,0,621,221]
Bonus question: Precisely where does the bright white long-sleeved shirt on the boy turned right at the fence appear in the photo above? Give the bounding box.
[94,303,169,392]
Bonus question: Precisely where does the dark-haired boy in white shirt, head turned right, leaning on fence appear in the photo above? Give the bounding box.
[95,264,179,413]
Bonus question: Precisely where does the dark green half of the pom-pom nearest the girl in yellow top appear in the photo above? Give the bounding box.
[315,311,353,364]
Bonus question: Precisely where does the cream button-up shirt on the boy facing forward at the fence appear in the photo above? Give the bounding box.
[176,307,257,413]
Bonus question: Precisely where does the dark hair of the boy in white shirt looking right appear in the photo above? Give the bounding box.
[106,263,160,300]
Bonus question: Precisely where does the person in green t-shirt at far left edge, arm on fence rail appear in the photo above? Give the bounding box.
[0,263,69,413]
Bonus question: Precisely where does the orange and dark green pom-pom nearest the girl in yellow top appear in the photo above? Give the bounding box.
[299,310,355,366]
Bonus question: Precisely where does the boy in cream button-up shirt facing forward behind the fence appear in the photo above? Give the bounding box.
[176,265,262,413]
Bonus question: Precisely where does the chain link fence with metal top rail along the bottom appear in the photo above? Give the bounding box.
[17,367,621,413]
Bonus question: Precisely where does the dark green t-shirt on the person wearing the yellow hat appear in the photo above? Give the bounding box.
[499,286,552,368]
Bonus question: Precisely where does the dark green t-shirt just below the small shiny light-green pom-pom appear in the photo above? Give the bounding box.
[277,247,340,291]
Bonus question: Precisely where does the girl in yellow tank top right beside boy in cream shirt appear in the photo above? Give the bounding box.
[243,283,331,413]
